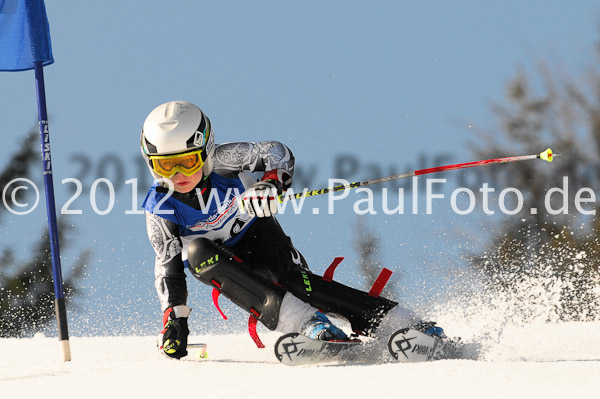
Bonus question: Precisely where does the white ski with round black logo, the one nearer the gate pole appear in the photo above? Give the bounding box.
[275,333,362,366]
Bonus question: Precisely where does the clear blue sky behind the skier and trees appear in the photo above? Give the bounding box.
[0,0,600,334]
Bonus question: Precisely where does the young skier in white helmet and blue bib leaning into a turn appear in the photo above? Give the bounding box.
[141,101,444,358]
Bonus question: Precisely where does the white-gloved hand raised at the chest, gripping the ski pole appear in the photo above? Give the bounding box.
[240,169,292,218]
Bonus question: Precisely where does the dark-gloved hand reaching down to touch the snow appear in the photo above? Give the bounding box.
[158,305,191,359]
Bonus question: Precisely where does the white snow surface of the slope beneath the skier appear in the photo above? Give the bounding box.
[0,322,600,399]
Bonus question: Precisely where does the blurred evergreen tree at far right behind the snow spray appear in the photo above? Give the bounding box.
[472,59,600,320]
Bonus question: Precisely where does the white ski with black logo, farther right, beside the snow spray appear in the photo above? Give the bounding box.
[388,328,464,363]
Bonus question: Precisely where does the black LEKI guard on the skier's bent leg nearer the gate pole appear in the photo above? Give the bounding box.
[188,238,286,330]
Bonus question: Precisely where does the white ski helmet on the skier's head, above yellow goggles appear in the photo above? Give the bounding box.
[141,101,215,179]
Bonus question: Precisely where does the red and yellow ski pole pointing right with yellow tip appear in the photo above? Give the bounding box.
[279,148,560,202]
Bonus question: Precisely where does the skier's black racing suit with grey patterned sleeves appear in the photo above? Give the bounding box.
[146,142,396,335]
